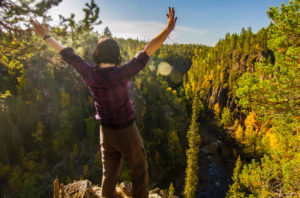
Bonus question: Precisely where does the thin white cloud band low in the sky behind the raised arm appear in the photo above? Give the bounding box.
[97,20,205,43]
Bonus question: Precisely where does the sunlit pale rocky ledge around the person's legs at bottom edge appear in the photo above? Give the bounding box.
[54,179,178,198]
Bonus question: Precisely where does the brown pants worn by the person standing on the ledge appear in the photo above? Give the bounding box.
[100,123,148,198]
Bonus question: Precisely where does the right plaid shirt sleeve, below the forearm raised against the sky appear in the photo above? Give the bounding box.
[120,51,150,82]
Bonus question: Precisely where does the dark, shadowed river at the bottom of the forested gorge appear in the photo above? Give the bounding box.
[197,120,235,198]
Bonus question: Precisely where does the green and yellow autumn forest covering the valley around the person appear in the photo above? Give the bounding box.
[0,0,300,198]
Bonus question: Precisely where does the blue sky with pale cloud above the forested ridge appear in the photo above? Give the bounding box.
[48,0,288,46]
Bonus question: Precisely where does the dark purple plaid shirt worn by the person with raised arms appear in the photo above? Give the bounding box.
[60,47,149,127]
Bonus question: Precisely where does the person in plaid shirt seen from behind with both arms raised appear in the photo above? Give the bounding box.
[30,7,177,198]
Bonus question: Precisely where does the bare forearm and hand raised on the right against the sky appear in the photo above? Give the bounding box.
[144,7,177,56]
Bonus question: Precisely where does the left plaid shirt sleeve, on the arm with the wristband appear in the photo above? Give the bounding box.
[59,47,92,83]
